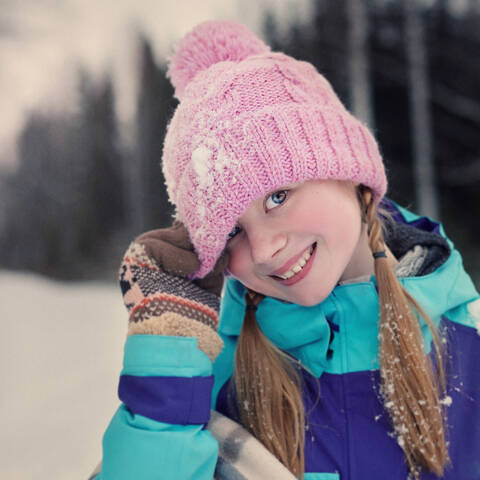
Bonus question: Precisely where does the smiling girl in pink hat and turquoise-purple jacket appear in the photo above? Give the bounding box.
[95,21,480,480]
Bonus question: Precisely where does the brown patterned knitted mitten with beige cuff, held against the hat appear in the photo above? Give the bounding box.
[119,221,228,361]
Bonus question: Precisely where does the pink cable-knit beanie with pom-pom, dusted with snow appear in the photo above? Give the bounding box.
[162,21,387,278]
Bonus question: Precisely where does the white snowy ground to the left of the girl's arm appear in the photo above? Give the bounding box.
[0,271,127,480]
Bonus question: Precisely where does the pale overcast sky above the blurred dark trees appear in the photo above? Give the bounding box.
[0,0,309,172]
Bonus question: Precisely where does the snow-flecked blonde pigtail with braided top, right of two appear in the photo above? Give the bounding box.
[361,187,449,478]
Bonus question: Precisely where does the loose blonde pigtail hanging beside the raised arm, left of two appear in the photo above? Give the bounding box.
[233,290,305,479]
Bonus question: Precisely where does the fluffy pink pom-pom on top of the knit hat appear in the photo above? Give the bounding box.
[167,20,270,99]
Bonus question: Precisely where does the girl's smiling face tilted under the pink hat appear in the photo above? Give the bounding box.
[227,180,373,306]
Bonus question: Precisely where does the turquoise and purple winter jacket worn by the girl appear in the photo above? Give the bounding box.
[95,200,480,480]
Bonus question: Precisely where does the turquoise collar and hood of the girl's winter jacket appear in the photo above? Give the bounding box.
[219,201,479,377]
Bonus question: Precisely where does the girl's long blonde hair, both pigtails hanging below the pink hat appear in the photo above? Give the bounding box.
[233,185,449,480]
